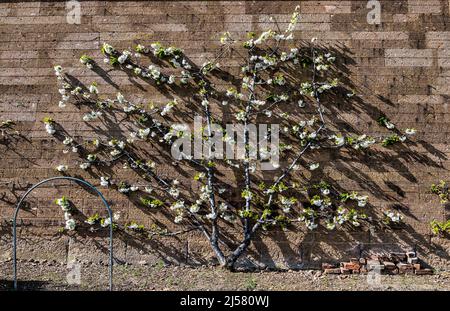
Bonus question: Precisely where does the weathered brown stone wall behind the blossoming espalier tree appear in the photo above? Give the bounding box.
[0,0,450,268]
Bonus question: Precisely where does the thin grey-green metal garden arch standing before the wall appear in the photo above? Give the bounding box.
[13,176,113,291]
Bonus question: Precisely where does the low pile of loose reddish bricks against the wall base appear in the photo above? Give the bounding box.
[322,252,433,275]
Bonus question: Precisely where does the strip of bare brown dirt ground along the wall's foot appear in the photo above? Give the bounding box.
[0,262,450,291]
